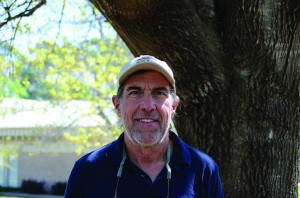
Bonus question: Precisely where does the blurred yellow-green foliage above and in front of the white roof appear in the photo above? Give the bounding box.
[0,34,128,150]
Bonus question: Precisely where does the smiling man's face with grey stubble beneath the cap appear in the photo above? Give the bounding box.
[113,71,179,147]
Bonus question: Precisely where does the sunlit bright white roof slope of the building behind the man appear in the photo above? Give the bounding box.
[0,98,115,130]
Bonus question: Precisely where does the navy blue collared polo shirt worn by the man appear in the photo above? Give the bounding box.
[65,131,224,198]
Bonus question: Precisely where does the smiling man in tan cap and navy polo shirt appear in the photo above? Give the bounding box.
[65,56,224,198]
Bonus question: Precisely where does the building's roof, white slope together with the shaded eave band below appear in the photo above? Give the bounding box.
[0,98,116,152]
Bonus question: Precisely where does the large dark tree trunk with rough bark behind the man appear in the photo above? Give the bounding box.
[92,0,300,198]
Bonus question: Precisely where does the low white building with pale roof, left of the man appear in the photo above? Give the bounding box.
[0,98,115,190]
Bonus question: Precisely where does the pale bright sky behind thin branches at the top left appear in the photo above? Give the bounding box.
[0,0,116,52]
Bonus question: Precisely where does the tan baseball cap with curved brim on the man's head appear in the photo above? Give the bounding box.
[118,55,175,88]
